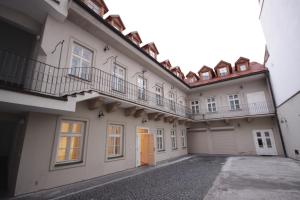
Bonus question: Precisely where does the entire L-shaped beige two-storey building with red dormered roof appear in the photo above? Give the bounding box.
[0,0,283,195]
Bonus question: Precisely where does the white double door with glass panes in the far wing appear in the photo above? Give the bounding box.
[253,129,278,155]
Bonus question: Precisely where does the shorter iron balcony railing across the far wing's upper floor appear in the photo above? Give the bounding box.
[192,102,275,120]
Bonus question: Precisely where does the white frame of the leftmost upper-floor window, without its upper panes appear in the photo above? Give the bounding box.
[69,41,94,80]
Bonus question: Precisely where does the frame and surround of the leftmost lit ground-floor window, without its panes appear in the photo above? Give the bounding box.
[50,117,88,170]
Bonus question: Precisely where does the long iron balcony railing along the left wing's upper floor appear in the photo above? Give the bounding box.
[0,51,191,118]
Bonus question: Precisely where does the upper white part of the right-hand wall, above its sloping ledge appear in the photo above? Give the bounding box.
[260,0,300,105]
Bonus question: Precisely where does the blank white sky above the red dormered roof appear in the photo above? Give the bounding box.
[105,0,265,74]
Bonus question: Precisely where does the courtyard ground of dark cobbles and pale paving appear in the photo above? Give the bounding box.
[10,156,300,200]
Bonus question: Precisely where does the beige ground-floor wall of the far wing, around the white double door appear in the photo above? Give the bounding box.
[188,117,283,155]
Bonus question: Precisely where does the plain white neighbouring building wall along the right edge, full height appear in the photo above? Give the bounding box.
[259,0,300,160]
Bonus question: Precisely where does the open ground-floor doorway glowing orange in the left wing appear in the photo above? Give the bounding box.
[136,127,155,167]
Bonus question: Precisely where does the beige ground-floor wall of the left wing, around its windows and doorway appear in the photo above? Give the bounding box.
[16,102,187,195]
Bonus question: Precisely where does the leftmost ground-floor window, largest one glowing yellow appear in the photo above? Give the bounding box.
[55,120,85,165]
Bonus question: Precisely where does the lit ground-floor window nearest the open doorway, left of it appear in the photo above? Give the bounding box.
[106,124,124,159]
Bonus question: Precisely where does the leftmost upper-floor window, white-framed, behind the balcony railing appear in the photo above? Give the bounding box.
[69,42,93,80]
